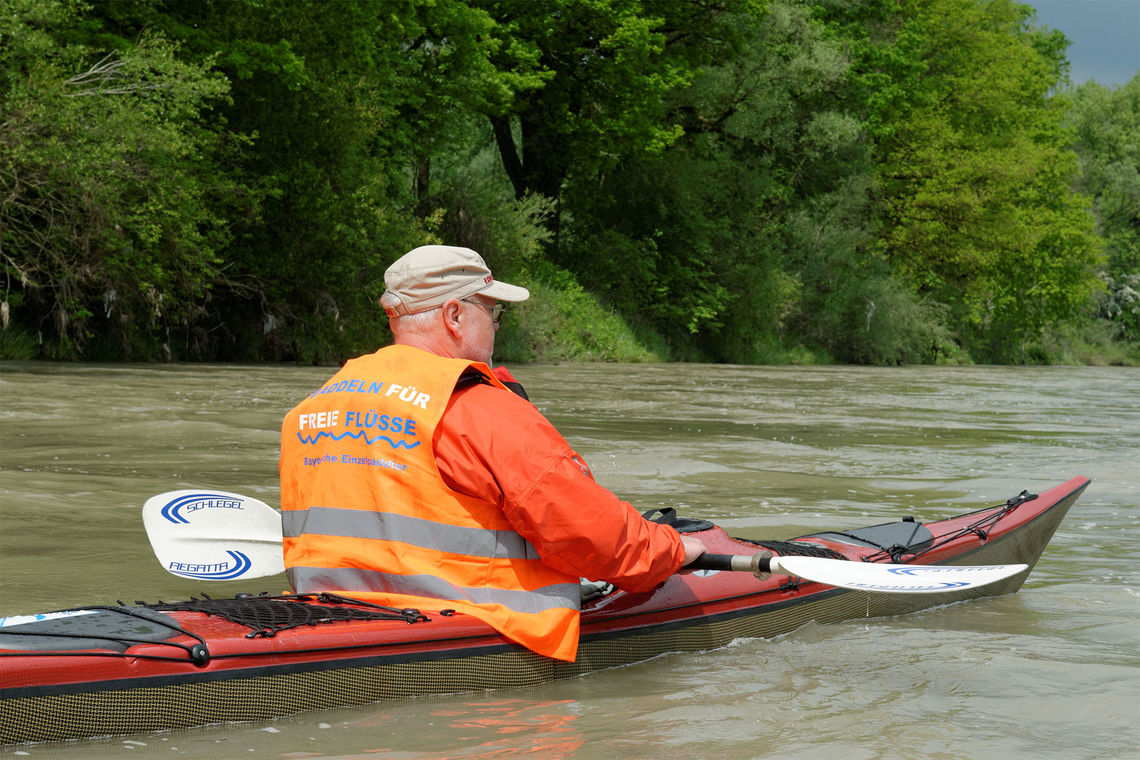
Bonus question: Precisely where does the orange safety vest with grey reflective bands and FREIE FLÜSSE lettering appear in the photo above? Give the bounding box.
[280,345,580,662]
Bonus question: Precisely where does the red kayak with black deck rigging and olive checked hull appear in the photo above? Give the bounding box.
[0,477,1090,744]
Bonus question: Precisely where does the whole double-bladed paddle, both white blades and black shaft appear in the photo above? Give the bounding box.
[143,490,1028,594]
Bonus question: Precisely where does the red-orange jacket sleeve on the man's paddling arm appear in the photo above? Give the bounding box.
[435,385,684,591]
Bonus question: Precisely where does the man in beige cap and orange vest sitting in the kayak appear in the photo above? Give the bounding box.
[280,245,705,661]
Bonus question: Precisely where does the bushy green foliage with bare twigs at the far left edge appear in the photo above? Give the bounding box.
[0,0,230,357]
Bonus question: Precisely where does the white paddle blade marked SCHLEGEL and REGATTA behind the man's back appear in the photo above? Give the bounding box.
[143,489,285,581]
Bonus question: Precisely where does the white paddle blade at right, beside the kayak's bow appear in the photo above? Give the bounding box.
[772,557,1029,594]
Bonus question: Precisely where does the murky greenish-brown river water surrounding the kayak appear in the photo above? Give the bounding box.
[0,362,1140,760]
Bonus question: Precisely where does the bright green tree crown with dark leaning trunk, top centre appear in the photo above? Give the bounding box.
[478,0,747,205]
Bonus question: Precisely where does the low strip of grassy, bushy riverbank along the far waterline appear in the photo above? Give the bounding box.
[0,267,1140,367]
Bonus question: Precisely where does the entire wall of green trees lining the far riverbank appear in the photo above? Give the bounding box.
[0,0,1121,365]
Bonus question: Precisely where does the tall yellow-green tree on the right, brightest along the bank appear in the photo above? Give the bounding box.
[861,0,1100,357]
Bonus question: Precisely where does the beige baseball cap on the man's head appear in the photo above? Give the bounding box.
[383,245,530,317]
